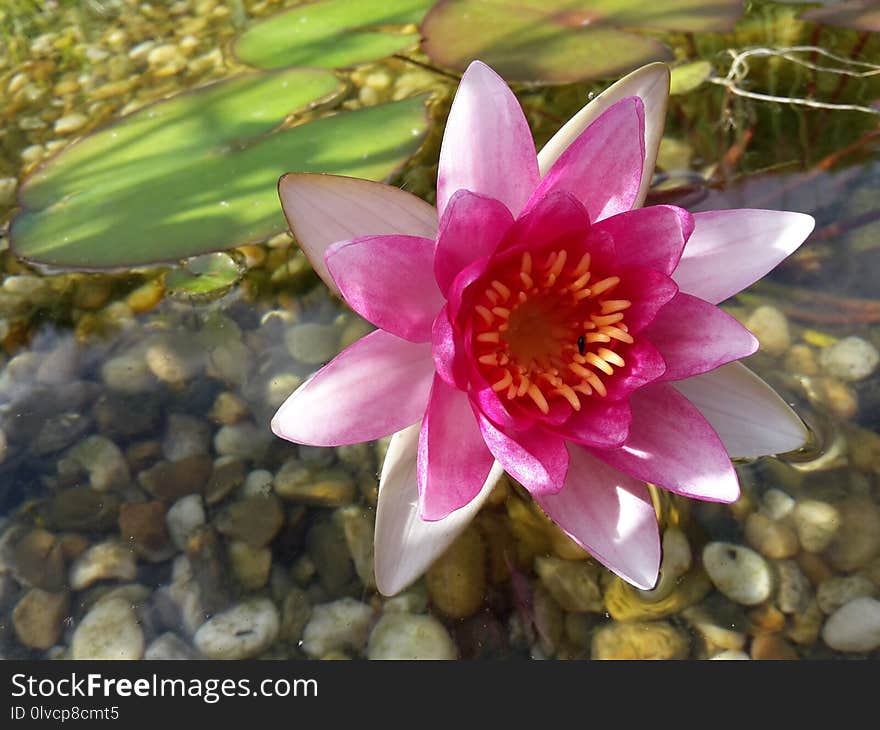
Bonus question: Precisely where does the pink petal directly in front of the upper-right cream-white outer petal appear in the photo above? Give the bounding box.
[527,96,645,222]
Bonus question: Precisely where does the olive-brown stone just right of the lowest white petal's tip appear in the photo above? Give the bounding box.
[425,524,486,618]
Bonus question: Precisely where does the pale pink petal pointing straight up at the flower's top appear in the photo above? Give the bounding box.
[437,61,538,216]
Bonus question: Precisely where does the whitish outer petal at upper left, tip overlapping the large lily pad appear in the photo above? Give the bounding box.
[278,173,437,294]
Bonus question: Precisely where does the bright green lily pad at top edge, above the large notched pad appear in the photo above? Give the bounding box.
[234,0,433,68]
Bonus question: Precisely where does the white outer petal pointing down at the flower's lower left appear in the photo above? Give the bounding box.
[375,422,504,596]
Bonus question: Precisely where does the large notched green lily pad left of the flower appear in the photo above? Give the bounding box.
[10,69,426,269]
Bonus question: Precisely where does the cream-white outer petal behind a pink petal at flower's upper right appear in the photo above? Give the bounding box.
[538,63,669,208]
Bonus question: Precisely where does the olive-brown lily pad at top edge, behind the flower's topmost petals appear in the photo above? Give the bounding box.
[421,0,742,84]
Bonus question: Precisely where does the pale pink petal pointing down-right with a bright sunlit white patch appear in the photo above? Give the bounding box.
[535,445,660,589]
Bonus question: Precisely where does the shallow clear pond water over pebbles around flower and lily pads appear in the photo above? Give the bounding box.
[0,0,880,659]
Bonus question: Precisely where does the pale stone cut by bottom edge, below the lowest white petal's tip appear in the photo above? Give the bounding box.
[367,613,458,659]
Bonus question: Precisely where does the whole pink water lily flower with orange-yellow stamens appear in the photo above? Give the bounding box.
[272,62,814,595]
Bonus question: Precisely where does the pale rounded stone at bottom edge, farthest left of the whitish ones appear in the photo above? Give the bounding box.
[71,598,144,659]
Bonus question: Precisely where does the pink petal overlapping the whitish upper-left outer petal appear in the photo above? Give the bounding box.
[325,236,444,342]
